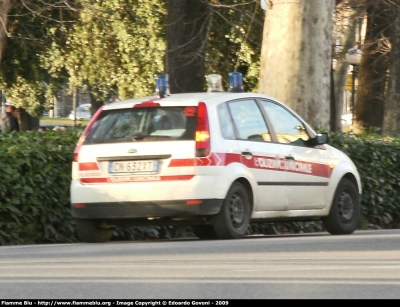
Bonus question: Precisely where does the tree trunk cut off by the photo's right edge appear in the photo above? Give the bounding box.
[383,0,400,136]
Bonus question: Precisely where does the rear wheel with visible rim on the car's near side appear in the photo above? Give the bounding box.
[212,182,250,239]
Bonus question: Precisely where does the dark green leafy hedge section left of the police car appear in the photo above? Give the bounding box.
[0,129,82,245]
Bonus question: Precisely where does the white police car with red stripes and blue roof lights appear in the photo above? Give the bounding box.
[71,75,361,242]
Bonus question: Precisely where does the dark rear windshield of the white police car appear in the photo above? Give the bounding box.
[85,107,197,145]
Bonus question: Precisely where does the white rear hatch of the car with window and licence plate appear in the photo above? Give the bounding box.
[73,103,203,184]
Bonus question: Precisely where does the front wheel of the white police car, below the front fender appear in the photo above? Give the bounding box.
[322,179,361,235]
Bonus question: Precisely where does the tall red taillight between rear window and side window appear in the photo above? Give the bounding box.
[195,102,210,157]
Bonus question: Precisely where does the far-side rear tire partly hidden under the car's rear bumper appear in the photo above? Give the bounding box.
[76,219,114,243]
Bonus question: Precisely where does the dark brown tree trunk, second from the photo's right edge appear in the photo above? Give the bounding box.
[353,0,391,133]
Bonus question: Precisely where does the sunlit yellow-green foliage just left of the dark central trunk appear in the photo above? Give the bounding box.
[42,0,166,100]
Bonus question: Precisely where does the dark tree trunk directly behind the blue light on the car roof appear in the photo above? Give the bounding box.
[166,0,209,93]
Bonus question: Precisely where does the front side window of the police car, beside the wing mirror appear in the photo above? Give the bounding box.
[262,100,310,146]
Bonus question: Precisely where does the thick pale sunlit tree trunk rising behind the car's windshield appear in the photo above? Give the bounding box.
[259,0,335,129]
